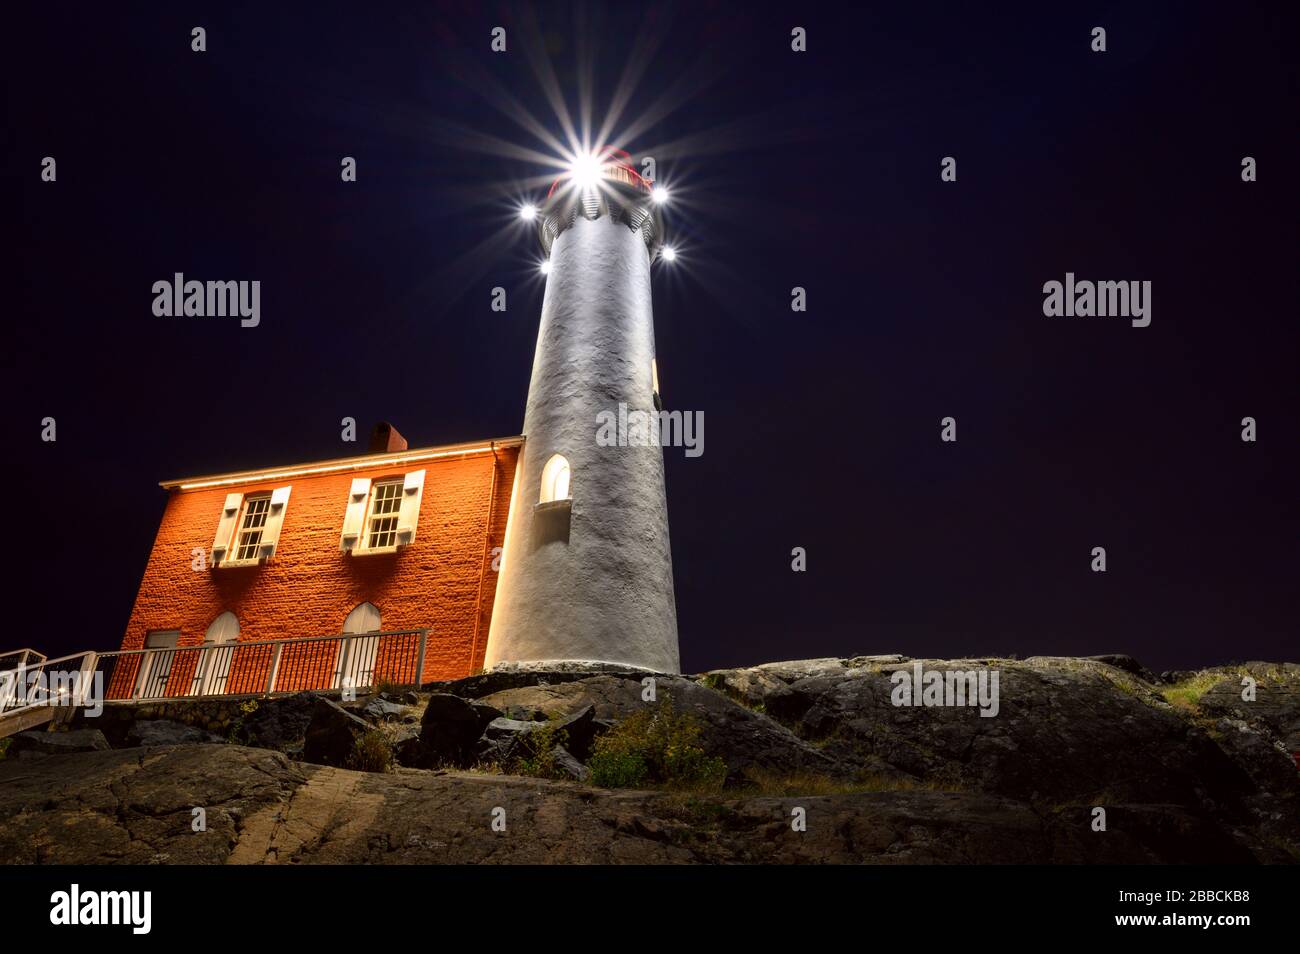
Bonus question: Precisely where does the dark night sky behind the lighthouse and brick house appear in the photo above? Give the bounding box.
[0,3,1300,671]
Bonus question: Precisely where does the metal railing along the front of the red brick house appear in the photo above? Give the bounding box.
[0,629,429,715]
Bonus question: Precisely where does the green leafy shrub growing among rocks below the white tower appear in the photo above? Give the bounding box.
[588,695,727,792]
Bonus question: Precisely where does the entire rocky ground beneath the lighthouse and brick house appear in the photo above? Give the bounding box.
[0,656,1300,864]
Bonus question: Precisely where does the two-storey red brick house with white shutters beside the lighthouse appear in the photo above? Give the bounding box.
[108,425,523,698]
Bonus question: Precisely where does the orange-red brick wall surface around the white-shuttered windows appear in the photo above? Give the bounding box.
[114,447,519,694]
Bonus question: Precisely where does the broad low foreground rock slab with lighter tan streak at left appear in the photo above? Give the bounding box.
[0,745,1258,866]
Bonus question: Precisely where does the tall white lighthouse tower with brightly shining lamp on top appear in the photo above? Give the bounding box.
[485,151,680,673]
